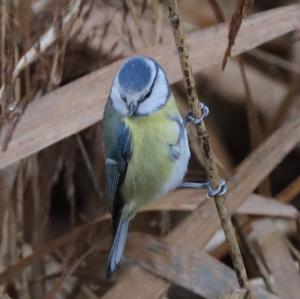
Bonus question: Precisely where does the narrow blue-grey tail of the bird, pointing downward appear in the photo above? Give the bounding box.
[106,217,129,278]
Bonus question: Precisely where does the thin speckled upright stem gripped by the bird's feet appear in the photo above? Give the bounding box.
[169,0,248,288]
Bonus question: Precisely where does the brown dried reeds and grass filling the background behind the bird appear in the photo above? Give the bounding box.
[0,0,300,299]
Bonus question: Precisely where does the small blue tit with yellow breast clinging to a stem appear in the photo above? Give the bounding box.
[103,56,190,277]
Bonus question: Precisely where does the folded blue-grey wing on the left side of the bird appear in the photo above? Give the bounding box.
[103,101,131,229]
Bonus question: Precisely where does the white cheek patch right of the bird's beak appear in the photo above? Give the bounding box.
[137,68,169,115]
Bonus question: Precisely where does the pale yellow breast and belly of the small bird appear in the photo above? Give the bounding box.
[121,96,179,214]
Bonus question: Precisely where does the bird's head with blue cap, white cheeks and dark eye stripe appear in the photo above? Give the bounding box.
[110,56,170,117]
